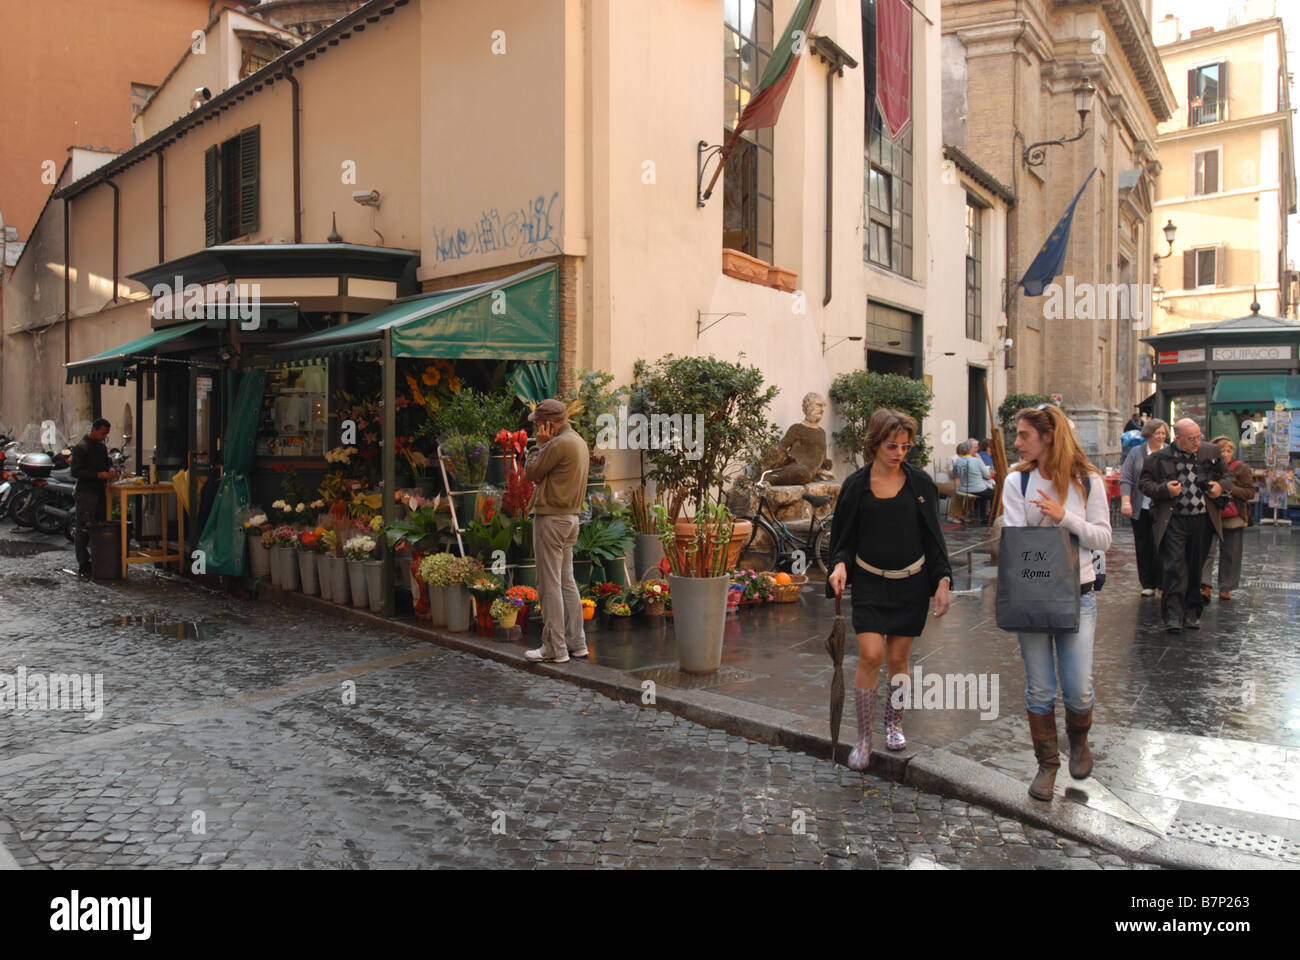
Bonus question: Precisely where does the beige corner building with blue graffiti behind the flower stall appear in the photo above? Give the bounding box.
[3,0,1011,481]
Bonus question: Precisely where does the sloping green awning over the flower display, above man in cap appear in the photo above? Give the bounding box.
[272,264,559,363]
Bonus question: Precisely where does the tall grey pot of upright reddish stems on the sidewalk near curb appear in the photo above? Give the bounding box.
[659,500,732,674]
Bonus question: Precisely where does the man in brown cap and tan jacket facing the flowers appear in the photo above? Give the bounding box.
[524,399,592,663]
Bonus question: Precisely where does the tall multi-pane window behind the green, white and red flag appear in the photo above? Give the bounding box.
[723,0,774,263]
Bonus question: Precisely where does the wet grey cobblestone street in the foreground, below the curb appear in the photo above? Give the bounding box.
[0,529,1145,869]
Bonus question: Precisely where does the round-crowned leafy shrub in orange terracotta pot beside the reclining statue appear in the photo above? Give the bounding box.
[632,354,781,570]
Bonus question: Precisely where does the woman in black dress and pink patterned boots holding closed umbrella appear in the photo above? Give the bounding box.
[827,410,952,770]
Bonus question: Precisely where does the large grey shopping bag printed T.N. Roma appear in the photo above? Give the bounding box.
[997,526,1079,633]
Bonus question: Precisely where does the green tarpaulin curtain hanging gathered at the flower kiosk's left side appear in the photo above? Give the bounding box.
[196,369,267,576]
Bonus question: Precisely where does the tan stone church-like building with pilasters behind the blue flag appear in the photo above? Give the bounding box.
[943,0,1175,464]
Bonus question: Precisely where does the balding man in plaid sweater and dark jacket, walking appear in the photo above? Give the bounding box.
[1138,419,1227,633]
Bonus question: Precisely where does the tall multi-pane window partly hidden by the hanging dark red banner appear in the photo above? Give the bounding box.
[862,0,913,277]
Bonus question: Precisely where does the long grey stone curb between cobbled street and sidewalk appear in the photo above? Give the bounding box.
[268,588,1300,870]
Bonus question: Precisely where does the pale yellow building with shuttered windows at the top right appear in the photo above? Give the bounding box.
[1154,4,1296,333]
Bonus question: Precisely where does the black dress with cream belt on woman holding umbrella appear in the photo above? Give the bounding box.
[849,483,930,636]
